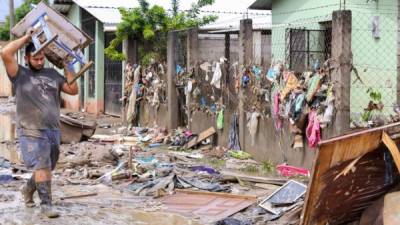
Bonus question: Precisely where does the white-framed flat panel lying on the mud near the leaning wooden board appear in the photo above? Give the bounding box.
[259,180,307,215]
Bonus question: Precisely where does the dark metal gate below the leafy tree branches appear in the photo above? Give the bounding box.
[104,32,123,116]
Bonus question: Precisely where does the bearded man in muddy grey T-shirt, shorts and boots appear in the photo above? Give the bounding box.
[0,31,78,218]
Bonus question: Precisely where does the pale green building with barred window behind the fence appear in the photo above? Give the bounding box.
[249,0,400,119]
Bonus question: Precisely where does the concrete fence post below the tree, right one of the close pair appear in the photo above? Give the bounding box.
[186,28,199,129]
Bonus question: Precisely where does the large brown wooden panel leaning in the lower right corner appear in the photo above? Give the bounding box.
[301,123,400,225]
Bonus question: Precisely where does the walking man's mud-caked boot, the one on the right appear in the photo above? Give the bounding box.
[36,181,60,218]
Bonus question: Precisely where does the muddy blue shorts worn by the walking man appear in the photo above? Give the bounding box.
[17,129,61,170]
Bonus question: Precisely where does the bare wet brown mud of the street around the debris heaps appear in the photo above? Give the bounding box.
[0,99,296,225]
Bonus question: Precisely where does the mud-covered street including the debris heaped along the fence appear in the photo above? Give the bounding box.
[0,98,306,225]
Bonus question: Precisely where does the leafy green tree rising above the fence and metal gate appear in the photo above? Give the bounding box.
[105,0,217,64]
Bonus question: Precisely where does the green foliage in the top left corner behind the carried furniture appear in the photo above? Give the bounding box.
[0,0,47,41]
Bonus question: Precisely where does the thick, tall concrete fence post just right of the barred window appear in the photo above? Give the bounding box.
[332,10,353,136]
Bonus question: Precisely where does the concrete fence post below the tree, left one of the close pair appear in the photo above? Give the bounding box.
[167,31,178,129]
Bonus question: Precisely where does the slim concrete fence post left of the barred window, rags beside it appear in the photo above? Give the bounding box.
[239,19,253,149]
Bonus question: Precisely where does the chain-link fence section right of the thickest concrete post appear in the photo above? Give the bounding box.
[350,10,398,124]
